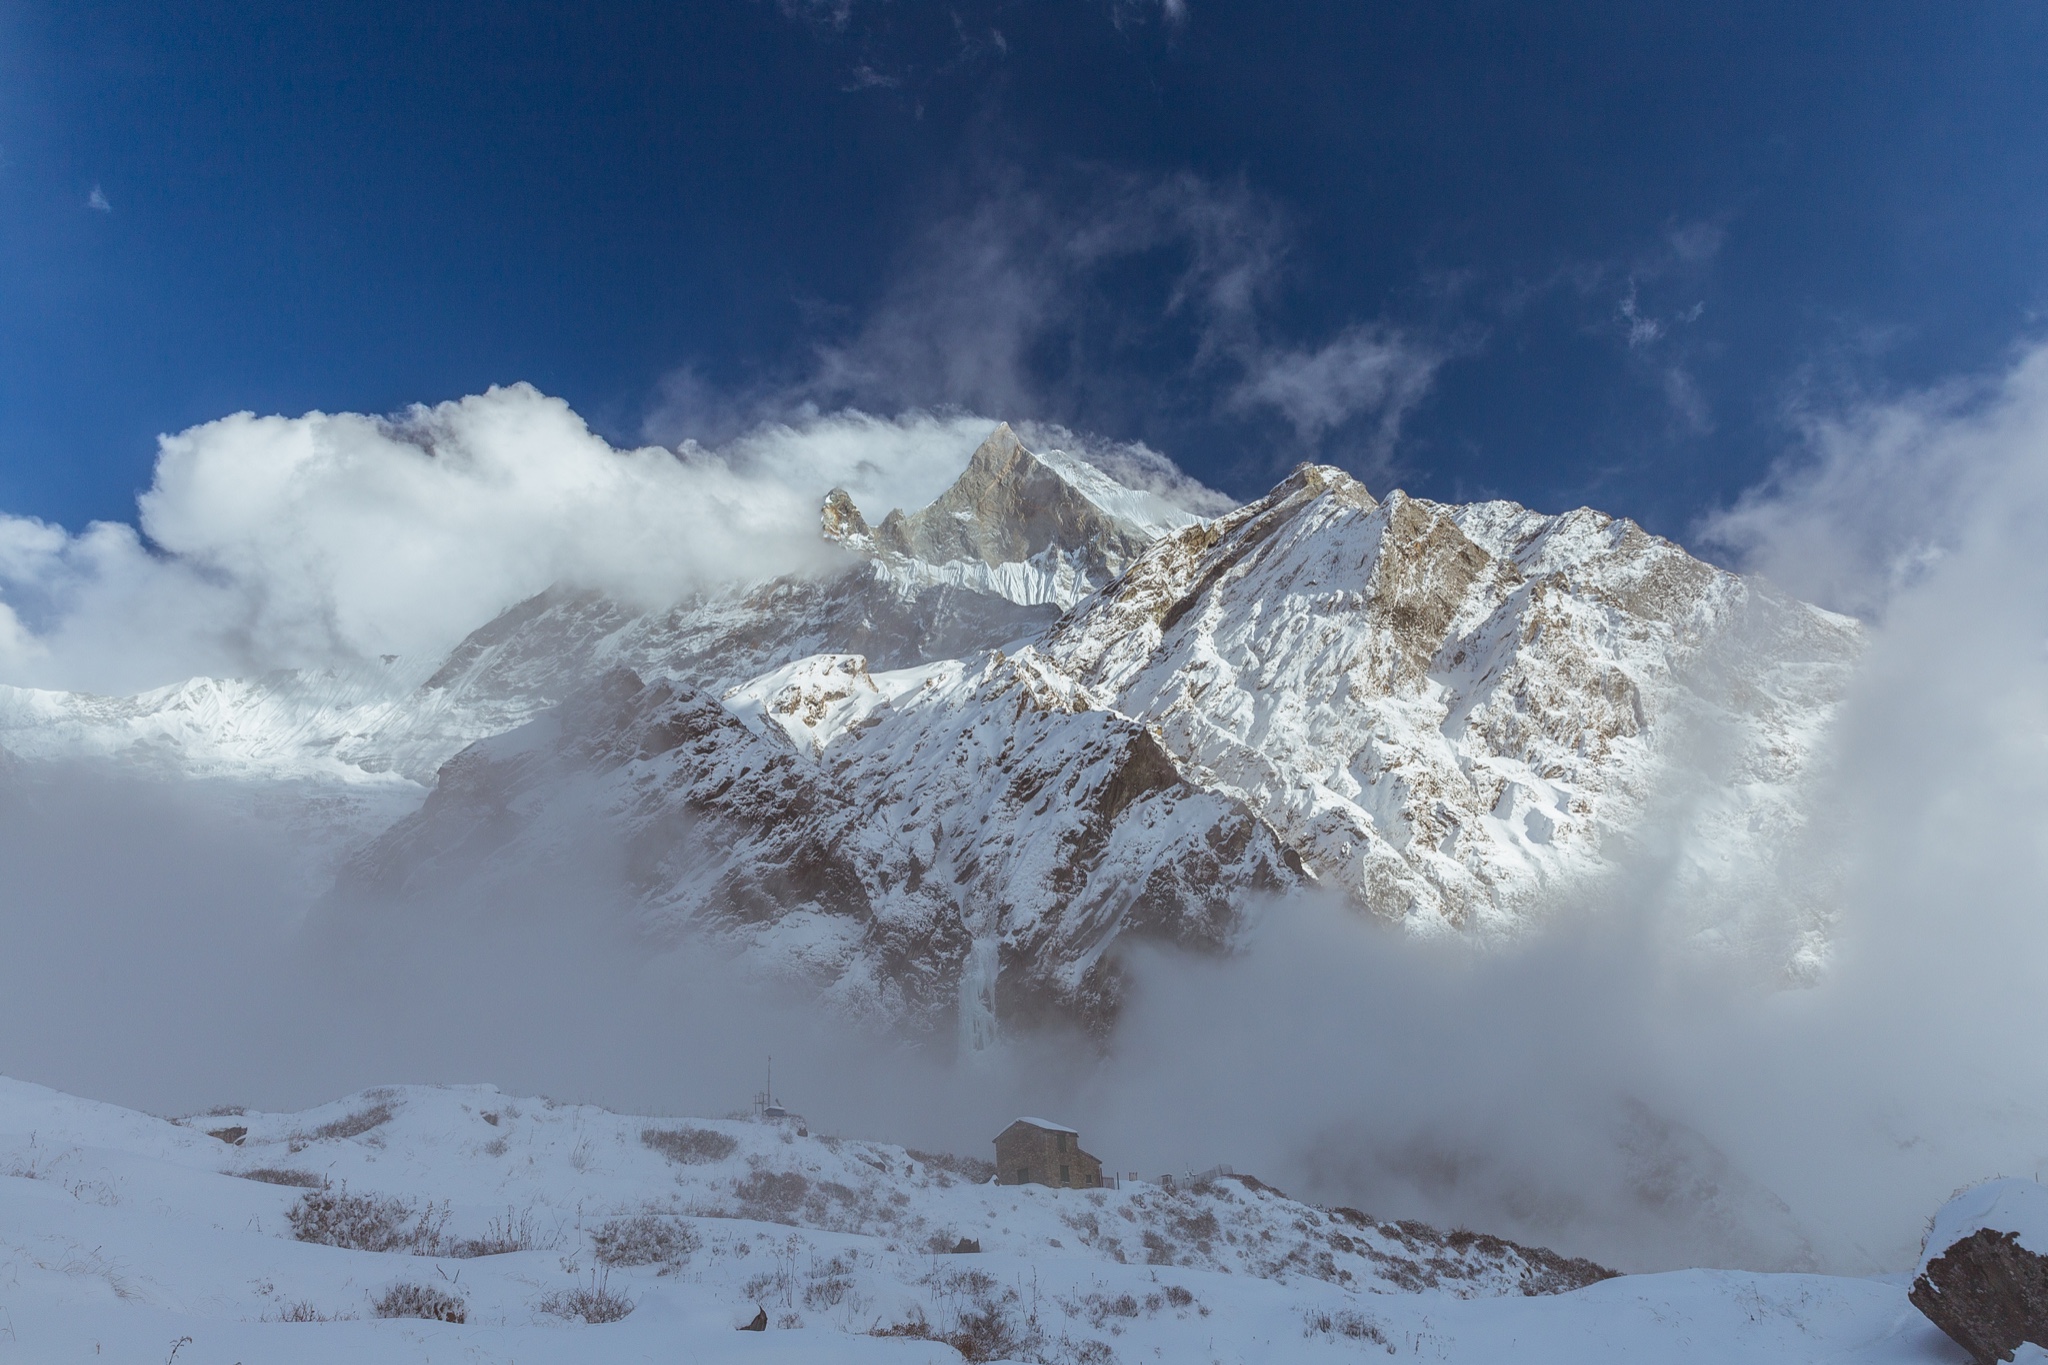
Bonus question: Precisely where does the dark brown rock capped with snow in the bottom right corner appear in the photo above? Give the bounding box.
[1909,1179,2048,1365]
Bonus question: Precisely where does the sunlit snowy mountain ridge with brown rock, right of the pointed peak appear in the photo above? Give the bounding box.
[1038,467,1860,929]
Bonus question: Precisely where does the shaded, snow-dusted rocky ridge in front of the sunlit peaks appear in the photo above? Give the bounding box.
[340,655,1296,1046]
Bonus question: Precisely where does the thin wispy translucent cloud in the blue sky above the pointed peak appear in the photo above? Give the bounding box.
[643,168,1460,474]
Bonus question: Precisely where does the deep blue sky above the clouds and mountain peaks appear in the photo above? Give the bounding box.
[0,0,2048,536]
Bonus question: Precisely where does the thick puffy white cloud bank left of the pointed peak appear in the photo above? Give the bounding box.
[0,385,1007,692]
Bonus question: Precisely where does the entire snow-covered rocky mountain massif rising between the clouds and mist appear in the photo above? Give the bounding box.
[0,426,1860,1046]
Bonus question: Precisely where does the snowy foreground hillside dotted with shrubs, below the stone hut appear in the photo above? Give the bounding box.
[0,1078,1966,1365]
